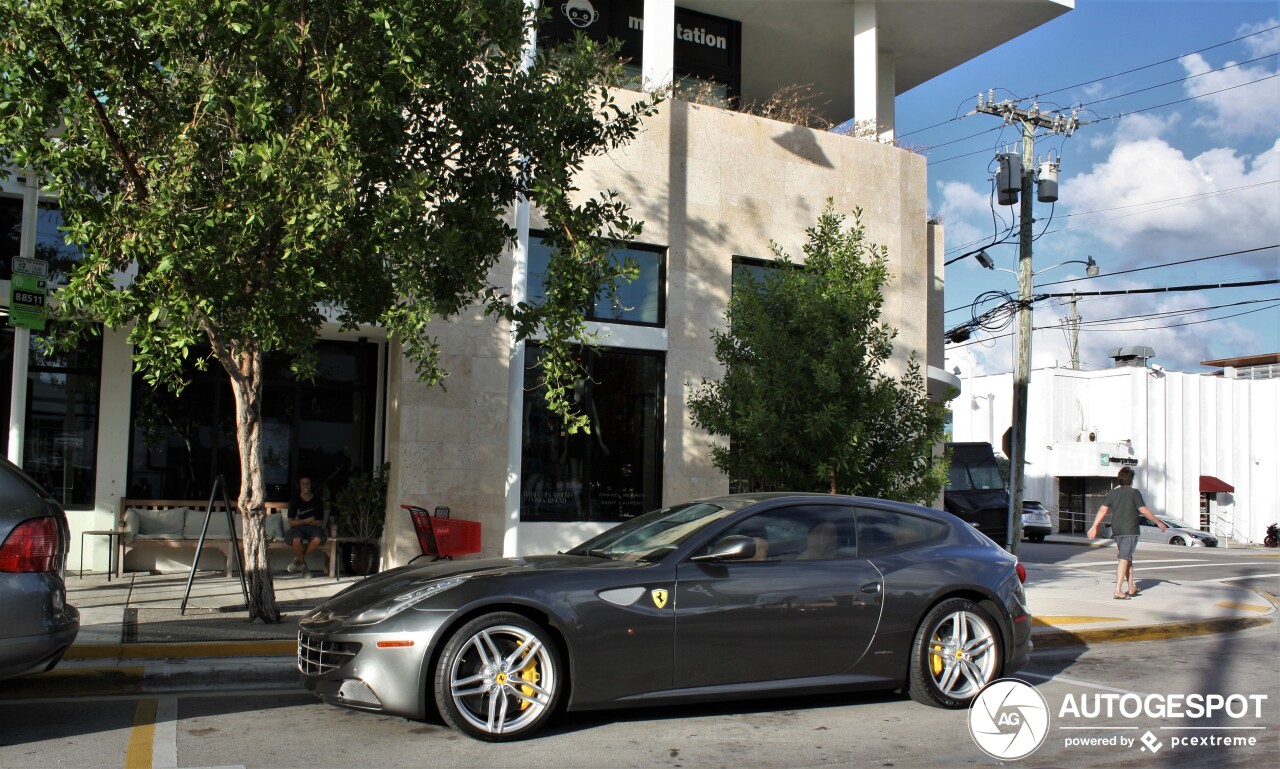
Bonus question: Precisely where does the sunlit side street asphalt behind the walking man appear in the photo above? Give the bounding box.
[1018,543,1280,596]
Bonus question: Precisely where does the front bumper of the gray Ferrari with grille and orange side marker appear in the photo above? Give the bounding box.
[297,609,453,719]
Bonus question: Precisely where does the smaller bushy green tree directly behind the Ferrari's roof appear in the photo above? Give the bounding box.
[689,201,946,503]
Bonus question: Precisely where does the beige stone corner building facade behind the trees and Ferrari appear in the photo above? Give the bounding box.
[0,0,1071,568]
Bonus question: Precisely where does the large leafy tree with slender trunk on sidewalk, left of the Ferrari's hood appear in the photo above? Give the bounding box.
[0,0,654,622]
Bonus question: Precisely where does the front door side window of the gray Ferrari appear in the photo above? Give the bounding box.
[708,504,858,562]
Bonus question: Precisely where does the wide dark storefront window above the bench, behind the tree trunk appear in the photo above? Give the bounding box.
[128,340,378,502]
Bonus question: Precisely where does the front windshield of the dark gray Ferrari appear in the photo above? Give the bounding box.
[568,502,740,560]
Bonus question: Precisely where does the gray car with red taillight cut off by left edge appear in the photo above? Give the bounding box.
[0,458,79,681]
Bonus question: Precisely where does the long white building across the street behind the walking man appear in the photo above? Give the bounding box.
[951,348,1280,543]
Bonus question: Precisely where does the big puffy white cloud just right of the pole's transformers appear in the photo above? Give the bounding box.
[1060,137,1280,261]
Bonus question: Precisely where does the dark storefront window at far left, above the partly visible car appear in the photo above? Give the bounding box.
[0,319,102,509]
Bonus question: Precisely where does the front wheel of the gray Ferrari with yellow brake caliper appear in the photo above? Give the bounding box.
[435,612,563,742]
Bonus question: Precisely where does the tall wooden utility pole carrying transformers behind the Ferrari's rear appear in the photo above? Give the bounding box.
[978,93,1079,555]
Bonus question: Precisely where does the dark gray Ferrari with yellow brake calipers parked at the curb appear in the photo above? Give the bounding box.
[297,494,1032,741]
